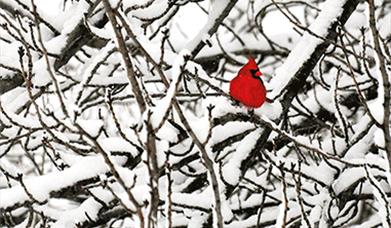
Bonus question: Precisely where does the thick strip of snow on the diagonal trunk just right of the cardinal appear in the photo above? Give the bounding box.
[268,0,346,99]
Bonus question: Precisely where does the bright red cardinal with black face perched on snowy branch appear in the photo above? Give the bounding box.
[229,57,266,108]
